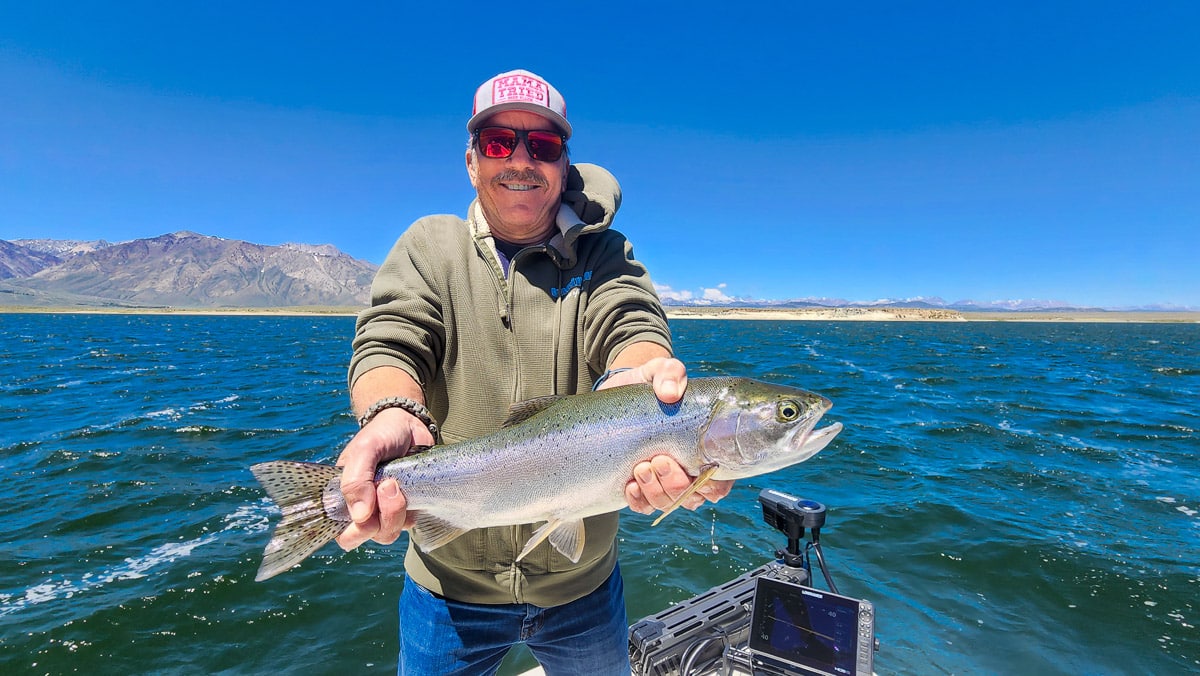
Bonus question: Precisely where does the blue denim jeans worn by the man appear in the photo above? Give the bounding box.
[397,568,630,676]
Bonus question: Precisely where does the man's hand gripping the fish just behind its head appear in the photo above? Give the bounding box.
[600,357,733,514]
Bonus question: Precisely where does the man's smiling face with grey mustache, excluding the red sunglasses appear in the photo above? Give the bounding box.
[467,110,568,244]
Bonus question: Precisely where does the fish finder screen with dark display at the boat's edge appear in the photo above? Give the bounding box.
[749,578,858,675]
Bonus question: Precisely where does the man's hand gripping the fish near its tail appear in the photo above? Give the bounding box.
[337,408,433,551]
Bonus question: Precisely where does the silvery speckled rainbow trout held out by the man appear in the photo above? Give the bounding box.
[251,377,841,580]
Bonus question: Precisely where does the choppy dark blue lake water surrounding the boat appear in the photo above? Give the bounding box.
[0,315,1200,674]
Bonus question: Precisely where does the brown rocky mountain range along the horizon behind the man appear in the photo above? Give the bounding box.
[0,232,1192,312]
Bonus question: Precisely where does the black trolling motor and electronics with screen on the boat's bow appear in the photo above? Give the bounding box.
[629,489,878,676]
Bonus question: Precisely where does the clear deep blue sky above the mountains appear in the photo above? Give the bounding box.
[0,0,1200,307]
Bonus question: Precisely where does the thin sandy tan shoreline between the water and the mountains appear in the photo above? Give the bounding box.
[0,305,1200,324]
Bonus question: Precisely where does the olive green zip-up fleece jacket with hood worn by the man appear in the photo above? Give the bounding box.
[349,164,671,606]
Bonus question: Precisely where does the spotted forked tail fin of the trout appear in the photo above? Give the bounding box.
[250,461,350,582]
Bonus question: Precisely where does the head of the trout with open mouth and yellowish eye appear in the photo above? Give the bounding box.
[700,378,841,479]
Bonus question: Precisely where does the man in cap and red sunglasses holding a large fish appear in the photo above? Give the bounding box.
[337,71,731,675]
